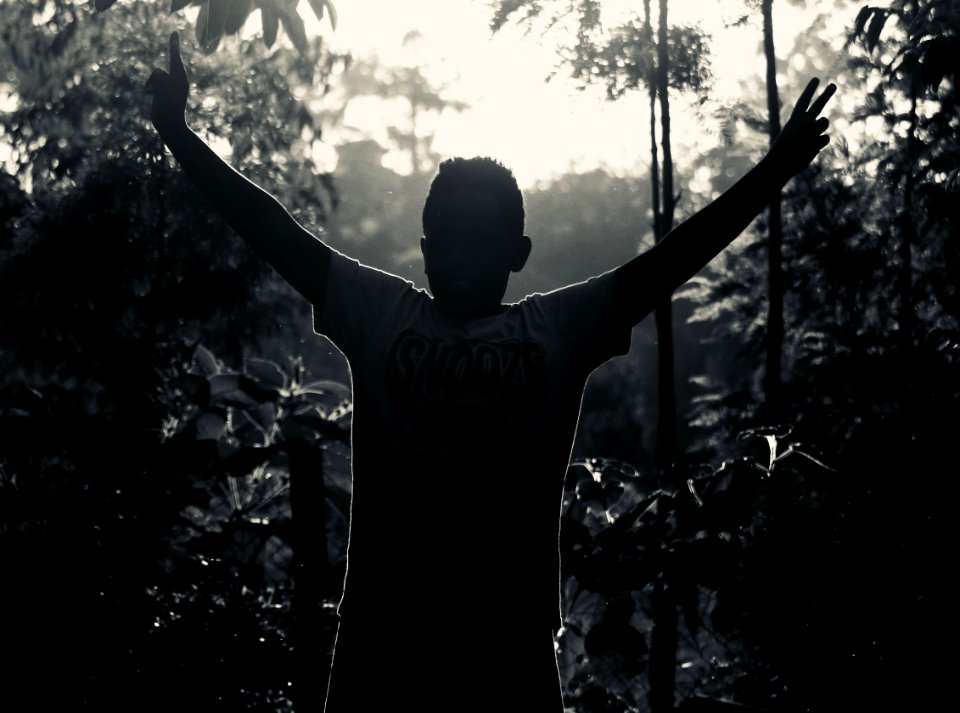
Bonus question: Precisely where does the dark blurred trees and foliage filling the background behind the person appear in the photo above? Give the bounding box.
[0,0,960,713]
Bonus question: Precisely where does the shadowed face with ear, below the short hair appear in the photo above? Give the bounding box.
[420,192,530,317]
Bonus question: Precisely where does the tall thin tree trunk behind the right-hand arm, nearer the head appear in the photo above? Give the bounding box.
[654,0,677,469]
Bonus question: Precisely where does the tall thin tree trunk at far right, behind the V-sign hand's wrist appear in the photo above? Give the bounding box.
[763,0,784,420]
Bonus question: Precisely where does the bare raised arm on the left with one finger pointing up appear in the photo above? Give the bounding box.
[146,33,331,306]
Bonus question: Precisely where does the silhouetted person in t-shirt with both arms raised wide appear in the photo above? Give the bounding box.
[147,34,835,713]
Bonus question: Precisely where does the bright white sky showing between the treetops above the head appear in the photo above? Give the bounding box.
[310,0,857,186]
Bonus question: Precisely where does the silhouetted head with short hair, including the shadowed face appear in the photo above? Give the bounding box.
[420,158,530,317]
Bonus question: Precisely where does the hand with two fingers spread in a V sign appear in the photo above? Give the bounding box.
[767,77,837,182]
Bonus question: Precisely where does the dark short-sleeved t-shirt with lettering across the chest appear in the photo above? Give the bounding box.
[314,252,630,629]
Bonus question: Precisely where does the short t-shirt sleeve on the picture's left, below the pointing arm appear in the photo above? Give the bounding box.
[313,250,416,359]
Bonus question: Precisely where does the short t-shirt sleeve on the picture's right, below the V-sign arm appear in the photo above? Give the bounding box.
[538,270,633,373]
